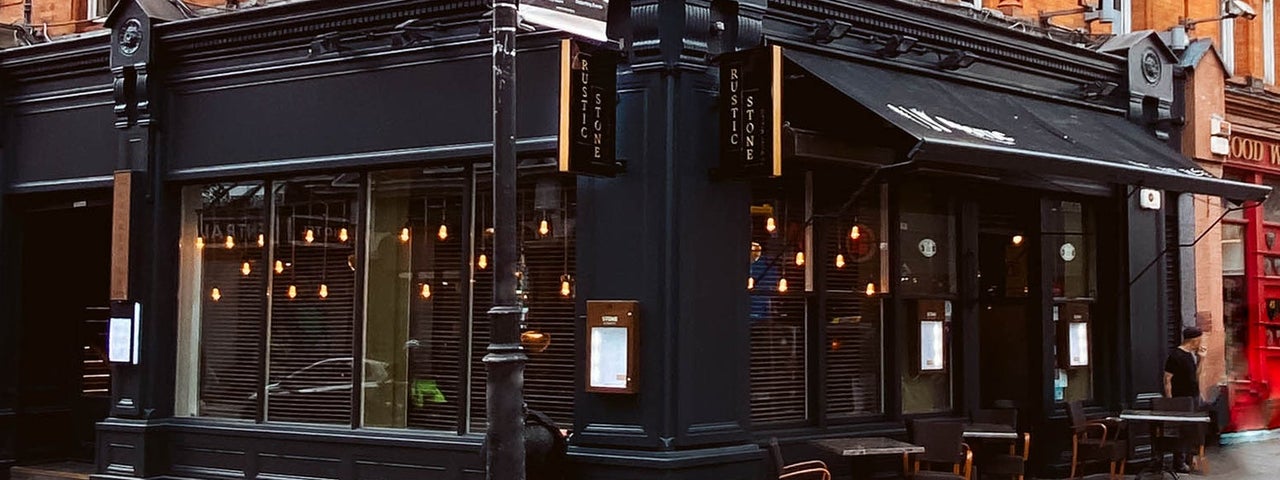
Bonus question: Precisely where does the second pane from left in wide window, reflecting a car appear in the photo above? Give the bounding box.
[266,175,355,424]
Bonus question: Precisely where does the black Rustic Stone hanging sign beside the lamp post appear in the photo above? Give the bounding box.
[559,40,620,175]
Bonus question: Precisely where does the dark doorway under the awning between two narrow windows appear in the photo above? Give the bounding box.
[978,198,1042,411]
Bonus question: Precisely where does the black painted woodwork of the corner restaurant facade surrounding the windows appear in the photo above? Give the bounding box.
[0,0,1259,479]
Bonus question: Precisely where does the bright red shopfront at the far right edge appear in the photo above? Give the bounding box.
[1222,129,1280,431]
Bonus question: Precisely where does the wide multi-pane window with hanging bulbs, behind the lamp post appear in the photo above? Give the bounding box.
[177,166,576,433]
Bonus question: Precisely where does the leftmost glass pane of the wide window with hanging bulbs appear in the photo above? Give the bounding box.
[179,182,268,420]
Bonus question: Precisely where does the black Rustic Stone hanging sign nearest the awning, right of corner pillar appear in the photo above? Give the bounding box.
[719,45,782,178]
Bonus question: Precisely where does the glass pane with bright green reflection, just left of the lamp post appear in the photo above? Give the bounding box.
[364,169,468,430]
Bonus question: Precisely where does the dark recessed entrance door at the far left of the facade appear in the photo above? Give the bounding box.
[15,201,111,463]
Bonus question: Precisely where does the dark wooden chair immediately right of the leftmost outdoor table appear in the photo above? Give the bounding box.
[906,420,973,480]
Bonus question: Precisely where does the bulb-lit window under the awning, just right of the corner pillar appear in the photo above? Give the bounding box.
[746,172,886,425]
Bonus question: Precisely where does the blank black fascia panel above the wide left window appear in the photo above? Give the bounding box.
[165,47,558,170]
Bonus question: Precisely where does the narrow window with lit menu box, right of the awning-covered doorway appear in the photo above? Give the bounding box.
[1042,201,1101,402]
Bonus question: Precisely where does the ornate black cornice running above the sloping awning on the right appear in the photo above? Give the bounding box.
[768,0,1126,82]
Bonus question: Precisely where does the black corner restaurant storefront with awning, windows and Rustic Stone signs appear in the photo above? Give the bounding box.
[0,0,1267,479]
